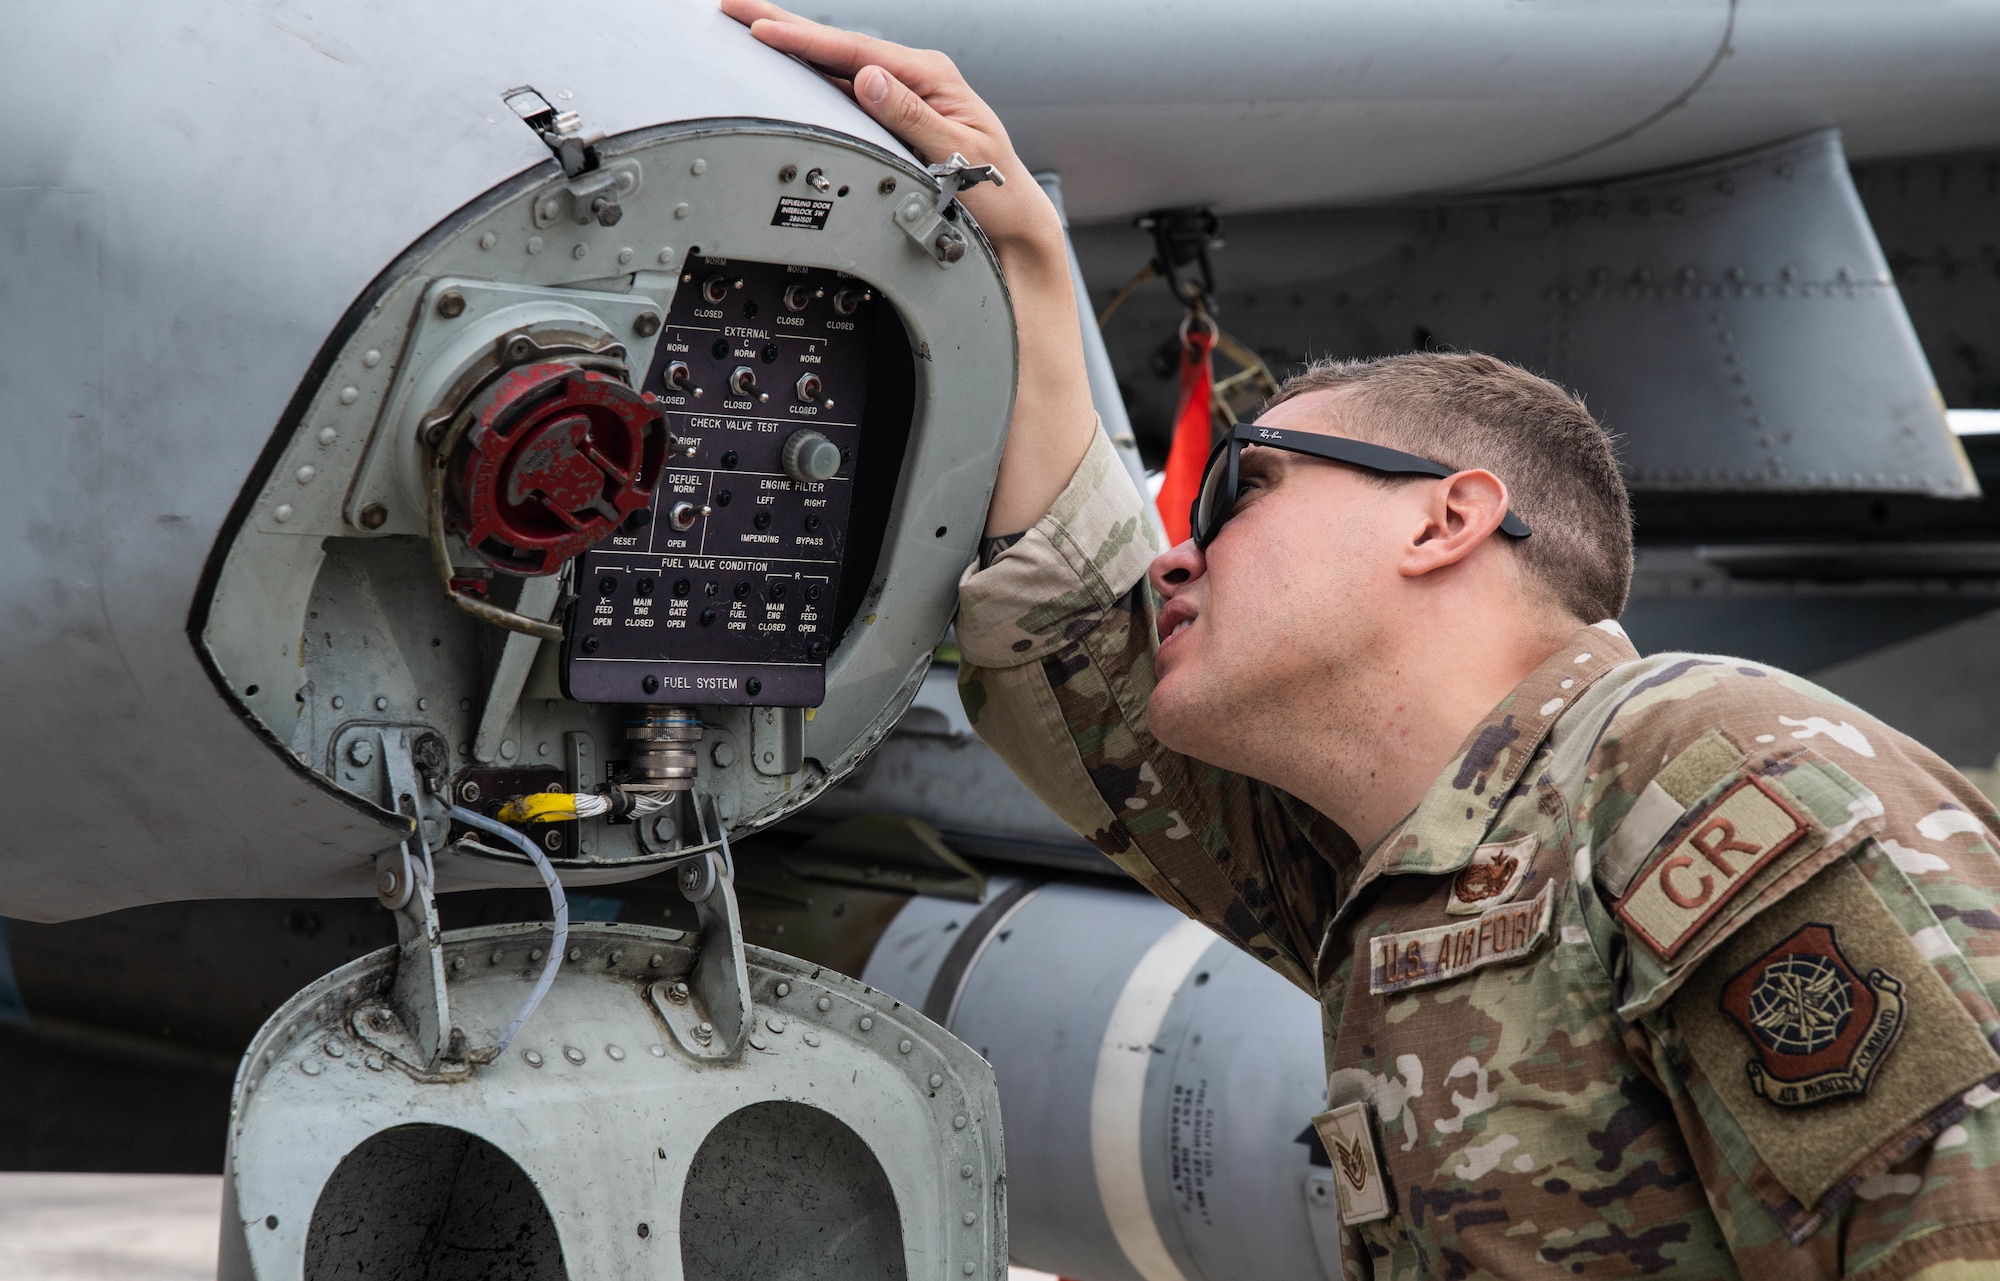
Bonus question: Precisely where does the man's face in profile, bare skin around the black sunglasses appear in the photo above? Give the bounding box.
[1146,392,1422,767]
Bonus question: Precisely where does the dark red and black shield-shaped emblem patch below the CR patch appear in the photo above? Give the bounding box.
[1722,921,1904,1107]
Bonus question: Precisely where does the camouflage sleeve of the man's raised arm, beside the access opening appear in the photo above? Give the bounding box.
[958,432,1356,995]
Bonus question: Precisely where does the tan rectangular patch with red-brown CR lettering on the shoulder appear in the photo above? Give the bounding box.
[1616,775,1812,961]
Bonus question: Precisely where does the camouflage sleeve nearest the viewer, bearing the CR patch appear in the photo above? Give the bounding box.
[1580,657,2000,1279]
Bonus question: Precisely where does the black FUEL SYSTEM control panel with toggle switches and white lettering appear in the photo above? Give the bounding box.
[562,254,880,707]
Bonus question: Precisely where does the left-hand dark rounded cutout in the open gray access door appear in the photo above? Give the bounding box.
[304,1125,568,1281]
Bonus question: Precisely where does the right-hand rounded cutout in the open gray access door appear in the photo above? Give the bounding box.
[680,1103,908,1281]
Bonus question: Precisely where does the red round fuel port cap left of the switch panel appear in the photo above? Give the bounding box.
[450,364,666,574]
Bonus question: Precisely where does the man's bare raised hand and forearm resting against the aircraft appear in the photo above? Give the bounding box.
[722,0,1096,534]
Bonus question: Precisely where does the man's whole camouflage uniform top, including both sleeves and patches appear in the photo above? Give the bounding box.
[958,440,2000,1281]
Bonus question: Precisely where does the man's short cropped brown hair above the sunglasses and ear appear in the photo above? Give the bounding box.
[1266,352,1632,622]
